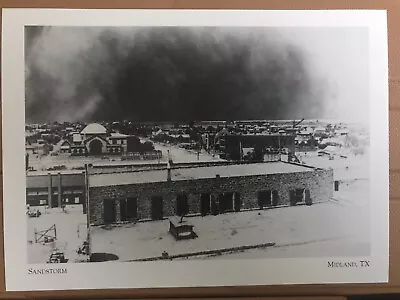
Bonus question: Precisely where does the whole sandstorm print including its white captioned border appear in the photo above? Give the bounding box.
[2,9,389,291]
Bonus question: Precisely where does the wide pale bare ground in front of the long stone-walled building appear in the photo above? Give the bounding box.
[91,180,369,261]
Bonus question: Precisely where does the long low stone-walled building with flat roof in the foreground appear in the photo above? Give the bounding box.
[88,161,334,225]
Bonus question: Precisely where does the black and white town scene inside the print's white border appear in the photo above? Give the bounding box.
[3,8,388,290]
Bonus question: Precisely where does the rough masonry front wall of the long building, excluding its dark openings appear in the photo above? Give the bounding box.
[89,168,334,225]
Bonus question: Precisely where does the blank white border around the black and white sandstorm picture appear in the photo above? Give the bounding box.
[2,9,389,291]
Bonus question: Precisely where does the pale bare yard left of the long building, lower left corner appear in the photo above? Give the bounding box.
[27,205,87,264]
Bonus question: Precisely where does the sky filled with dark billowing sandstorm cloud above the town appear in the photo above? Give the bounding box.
[25,27,369,123]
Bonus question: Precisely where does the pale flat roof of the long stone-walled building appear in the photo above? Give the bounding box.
[89,161,314,187]
